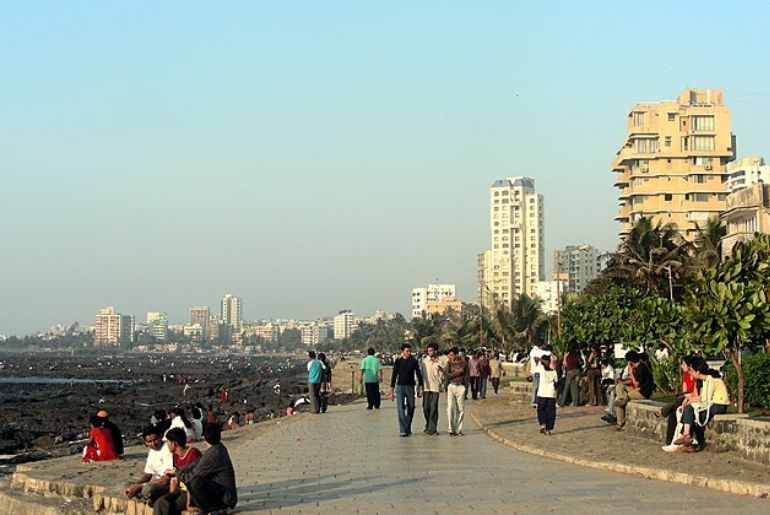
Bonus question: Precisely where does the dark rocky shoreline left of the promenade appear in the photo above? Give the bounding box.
[0,353,306,474]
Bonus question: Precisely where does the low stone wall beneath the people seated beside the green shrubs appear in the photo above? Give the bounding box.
[626,401,770,465]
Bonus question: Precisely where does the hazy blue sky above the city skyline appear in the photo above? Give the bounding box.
[0,1,770,335]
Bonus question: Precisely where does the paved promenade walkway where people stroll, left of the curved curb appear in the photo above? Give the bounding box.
[233,395,770,514]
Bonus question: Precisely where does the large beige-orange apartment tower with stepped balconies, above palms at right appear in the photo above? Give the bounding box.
[612,89,735,240]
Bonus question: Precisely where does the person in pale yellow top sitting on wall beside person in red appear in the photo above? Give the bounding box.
[674,359,730,452]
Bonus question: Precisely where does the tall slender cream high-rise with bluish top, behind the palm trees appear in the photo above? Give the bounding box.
[478,177,545,306]
